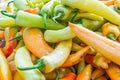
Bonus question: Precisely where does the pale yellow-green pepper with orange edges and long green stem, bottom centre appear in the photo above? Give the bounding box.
[18,40,72,73]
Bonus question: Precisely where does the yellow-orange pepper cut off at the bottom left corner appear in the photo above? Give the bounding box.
[0,49,12,80]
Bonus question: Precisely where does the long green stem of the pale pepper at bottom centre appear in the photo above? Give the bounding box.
[18,59,45,72]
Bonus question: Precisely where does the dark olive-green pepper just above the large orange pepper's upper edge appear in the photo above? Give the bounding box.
[81,18,105,31]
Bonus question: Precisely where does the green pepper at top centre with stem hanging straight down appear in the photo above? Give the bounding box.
[40,0,60,29]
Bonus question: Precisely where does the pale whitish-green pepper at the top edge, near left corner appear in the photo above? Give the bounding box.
[13,0,30,10]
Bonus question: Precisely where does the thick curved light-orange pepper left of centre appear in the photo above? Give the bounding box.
[23,28,53,58]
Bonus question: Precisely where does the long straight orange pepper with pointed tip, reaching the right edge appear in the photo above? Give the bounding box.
[69,23,120,65]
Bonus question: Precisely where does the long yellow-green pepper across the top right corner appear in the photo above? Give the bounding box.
[61,0,120,25]
